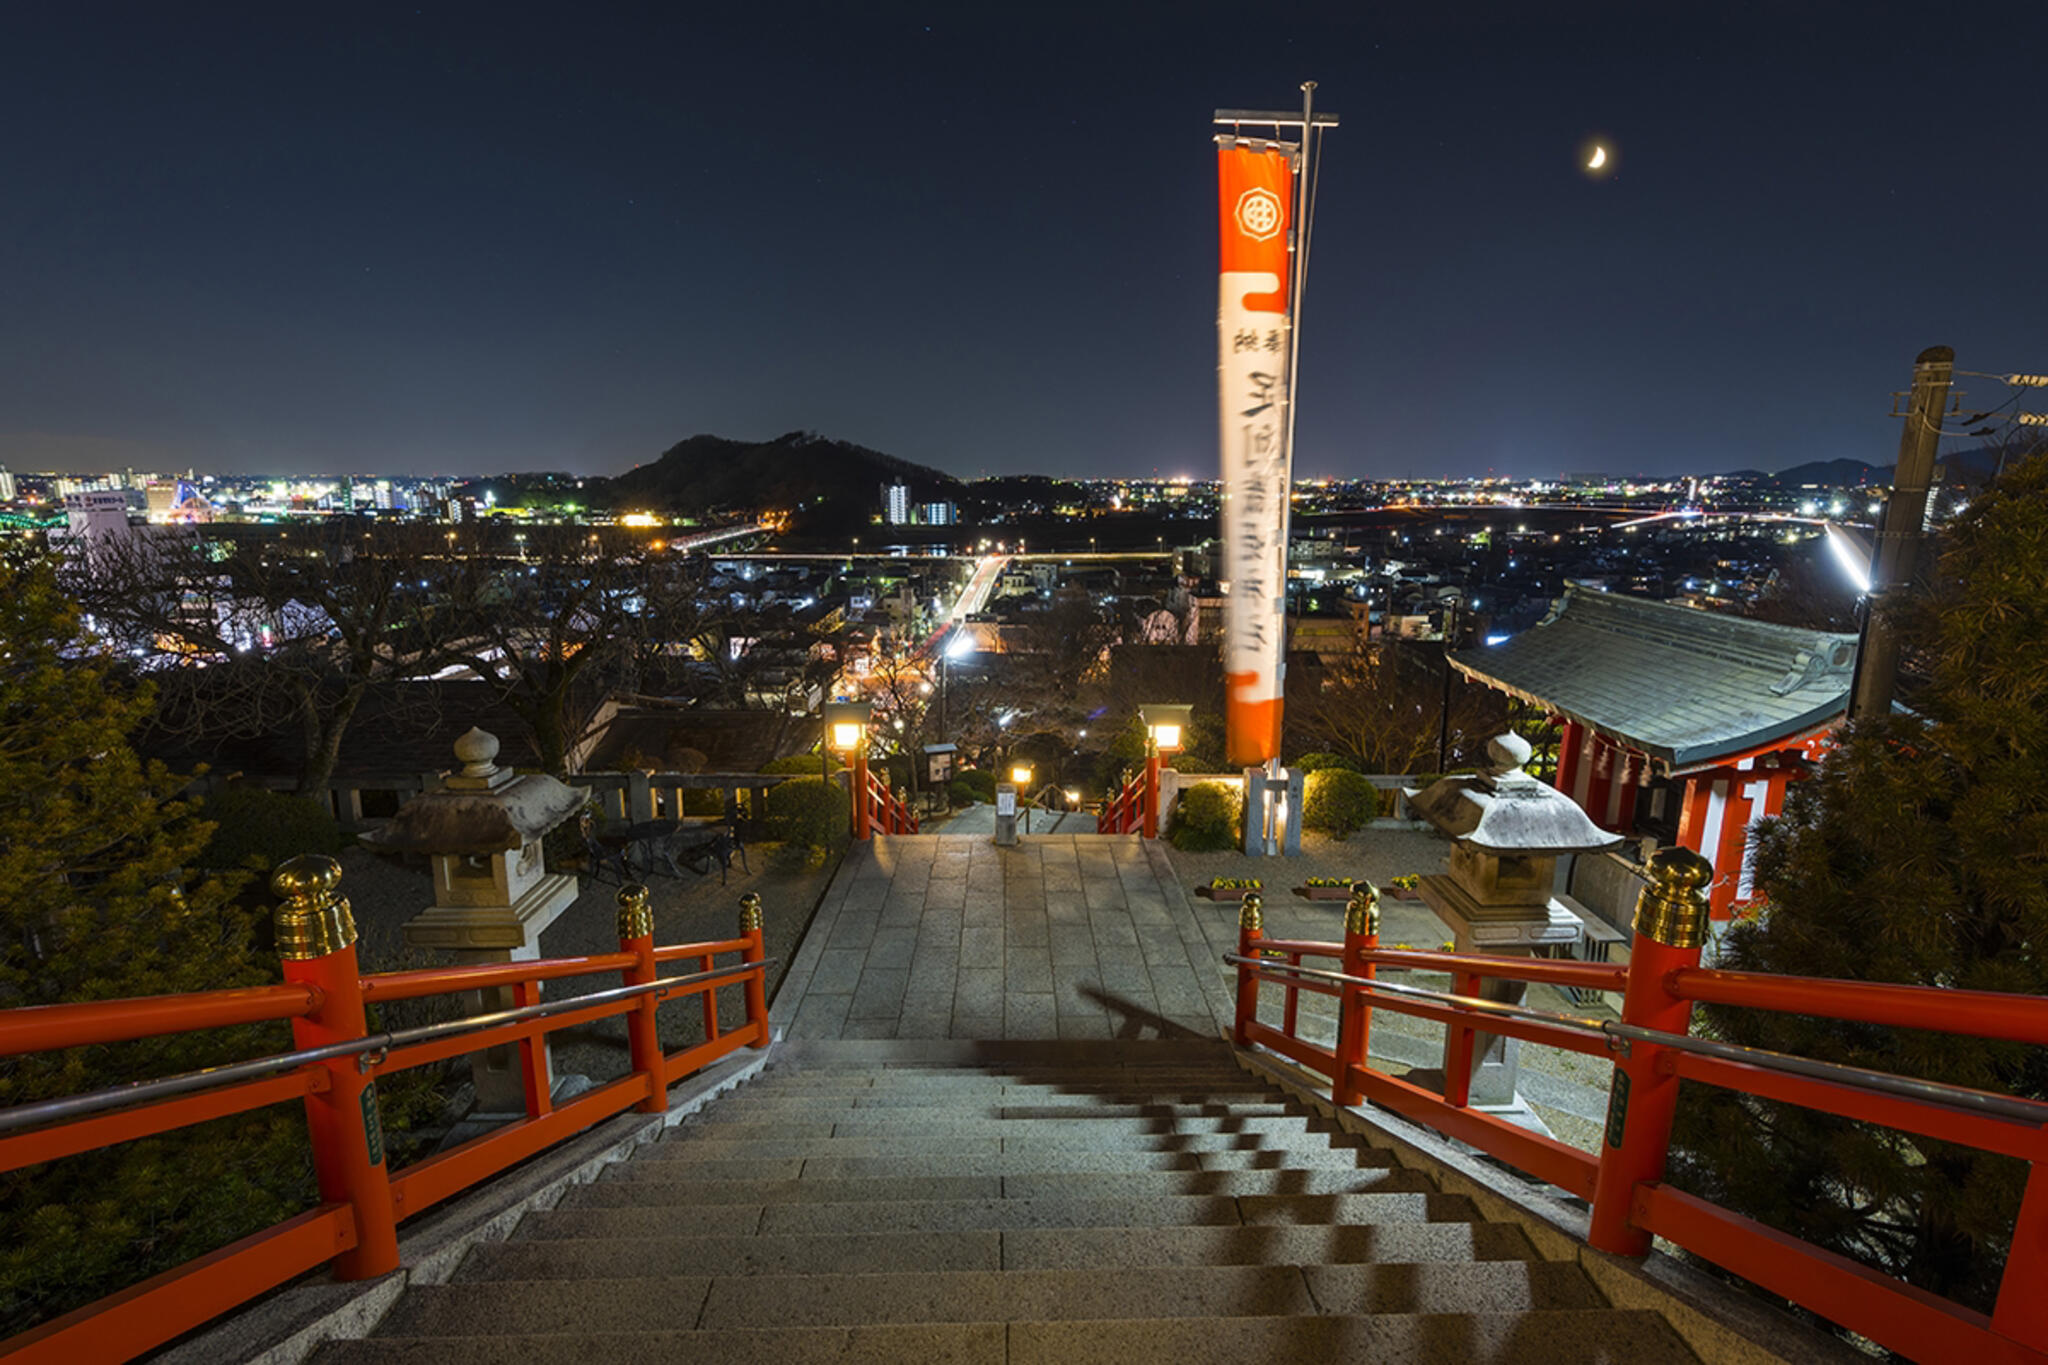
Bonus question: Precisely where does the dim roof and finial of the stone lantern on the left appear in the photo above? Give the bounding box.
[362,726,586,853]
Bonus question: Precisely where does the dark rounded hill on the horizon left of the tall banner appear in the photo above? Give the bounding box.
[586,432,961,514]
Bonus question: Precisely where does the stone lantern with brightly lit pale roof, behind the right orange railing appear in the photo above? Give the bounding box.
[1407,735,1620,1126]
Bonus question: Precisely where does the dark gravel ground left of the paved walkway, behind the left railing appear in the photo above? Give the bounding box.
[340,845,838,1101]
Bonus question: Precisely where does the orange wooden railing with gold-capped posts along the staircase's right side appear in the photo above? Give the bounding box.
[1233,849,2048,1363]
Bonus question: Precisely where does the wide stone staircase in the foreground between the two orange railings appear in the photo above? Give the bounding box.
[313,1042,1698,1365]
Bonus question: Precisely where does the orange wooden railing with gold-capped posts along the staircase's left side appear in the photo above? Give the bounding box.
[0,857,770,1365]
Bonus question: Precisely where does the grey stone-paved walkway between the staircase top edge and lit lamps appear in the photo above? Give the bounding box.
[772,833,1237,1040]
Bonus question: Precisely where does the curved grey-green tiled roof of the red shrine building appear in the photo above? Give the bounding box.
[1450,583,1855,769]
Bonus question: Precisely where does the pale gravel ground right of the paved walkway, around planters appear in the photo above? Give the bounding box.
[1161,829,1614,1152]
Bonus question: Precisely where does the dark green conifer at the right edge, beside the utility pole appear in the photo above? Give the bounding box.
[1673,456,2048,1312]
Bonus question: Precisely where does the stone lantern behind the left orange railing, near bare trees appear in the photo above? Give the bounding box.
[362,729,584,1115]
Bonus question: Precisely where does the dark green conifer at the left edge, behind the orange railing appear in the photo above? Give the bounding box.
[0,557,309,1334]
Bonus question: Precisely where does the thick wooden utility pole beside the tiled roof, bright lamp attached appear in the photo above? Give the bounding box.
[1849,346,1956,720]
